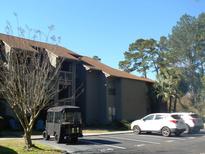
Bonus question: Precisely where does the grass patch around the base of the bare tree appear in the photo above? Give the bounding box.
[0,139,62,154]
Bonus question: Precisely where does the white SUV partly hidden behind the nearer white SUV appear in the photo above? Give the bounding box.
[174,112,204,133]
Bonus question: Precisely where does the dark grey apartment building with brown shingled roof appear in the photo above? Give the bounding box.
[0,34,153,125]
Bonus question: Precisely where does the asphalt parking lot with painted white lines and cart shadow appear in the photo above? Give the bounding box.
[38,130,205,154]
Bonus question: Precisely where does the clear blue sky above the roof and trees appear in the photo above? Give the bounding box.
[0,0,205,79]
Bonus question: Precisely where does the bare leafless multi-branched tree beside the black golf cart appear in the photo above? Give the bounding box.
[0,39,62,149]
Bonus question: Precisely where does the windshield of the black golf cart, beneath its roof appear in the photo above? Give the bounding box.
[63,112,81,123]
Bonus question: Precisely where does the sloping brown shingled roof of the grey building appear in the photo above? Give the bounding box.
[0,33,154,83]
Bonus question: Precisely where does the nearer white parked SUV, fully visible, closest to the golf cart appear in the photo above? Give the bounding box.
[131,113,186,136]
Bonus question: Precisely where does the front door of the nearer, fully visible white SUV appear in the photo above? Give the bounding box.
[140,114,155,131]
